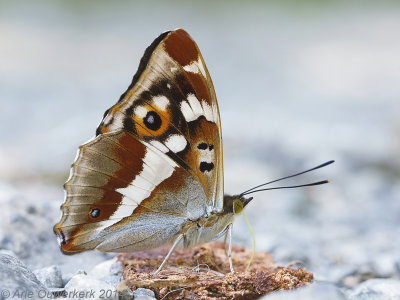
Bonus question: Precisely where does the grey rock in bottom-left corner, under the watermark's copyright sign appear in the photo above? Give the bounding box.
[0,250,48,299]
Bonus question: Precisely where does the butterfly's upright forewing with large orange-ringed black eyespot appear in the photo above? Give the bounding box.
[98,29,223,210]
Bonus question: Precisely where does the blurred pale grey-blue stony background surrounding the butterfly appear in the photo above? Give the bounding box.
[0,0,400,292]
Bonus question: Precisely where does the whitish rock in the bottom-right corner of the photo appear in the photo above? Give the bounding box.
[348,279,400,300]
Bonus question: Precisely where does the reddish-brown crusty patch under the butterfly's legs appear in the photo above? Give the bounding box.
[118,242,313,299]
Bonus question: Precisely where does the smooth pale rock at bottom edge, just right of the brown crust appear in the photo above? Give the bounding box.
[262,282,346,300]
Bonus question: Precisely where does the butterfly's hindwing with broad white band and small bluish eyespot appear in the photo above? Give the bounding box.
[54,131,205,253]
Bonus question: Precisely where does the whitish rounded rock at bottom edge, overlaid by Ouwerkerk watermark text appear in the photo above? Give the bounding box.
[65,274,118,300]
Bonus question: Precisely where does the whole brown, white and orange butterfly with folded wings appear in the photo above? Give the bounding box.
[54,29,332,274]
